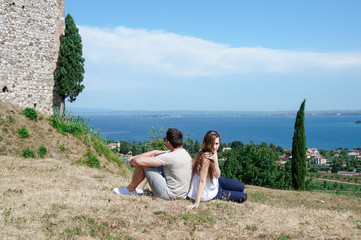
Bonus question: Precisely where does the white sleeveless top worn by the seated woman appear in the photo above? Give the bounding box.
[188,173,219,201]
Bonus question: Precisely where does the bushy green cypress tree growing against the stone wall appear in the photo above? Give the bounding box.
[55,14,85,111]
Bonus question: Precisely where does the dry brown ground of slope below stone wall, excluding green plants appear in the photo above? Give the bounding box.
[0,102,129,174]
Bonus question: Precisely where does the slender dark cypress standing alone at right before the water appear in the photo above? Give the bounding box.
[291,100,307,190]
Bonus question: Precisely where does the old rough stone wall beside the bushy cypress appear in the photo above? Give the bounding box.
[0,0,64,115]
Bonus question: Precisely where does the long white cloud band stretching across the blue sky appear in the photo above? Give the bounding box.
[79,26,361,77]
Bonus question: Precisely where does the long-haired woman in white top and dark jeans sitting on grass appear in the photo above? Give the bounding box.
[187,131,247,210]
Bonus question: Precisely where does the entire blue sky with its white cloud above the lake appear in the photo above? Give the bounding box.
[65,0,361,111]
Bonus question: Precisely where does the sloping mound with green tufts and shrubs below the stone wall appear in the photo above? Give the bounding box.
[0,102,127,174]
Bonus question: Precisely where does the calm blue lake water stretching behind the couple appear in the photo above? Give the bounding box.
[79,114,361,149]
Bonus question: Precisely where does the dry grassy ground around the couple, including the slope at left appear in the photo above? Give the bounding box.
[0,103,361,239]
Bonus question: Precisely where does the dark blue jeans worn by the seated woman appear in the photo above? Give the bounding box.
[213,176,247,202]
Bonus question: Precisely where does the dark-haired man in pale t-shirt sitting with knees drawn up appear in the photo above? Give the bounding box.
[114,128,192,200]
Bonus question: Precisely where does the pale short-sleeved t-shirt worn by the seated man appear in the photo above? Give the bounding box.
[156,148,192,198]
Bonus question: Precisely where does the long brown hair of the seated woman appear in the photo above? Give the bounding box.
[192,130,221,182]
